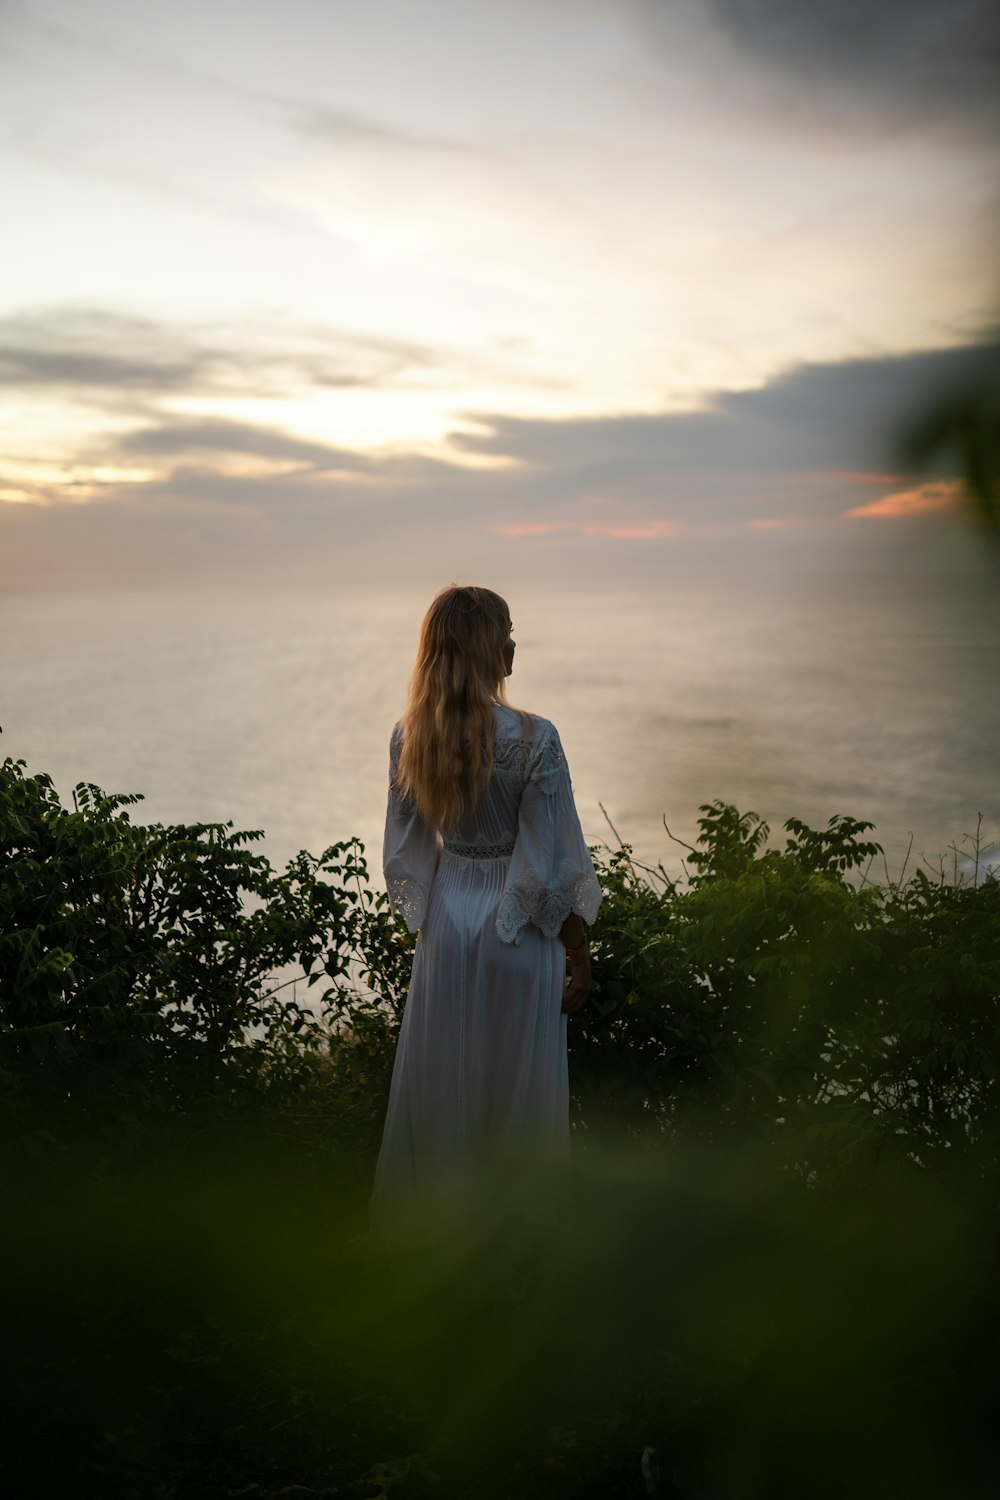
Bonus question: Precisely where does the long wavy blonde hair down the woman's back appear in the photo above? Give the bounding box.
[397,584,511,833]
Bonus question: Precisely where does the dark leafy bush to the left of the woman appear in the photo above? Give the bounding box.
[0,744,409,1152]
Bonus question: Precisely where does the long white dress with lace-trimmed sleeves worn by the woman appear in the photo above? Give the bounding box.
[372,707,601,1220]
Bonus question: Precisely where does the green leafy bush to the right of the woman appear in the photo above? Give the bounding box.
[571,803,1000,1175]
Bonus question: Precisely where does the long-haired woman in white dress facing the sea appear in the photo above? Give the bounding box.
[372,585,601,1214]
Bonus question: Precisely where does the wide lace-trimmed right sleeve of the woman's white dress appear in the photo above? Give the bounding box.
[496,720,603,944]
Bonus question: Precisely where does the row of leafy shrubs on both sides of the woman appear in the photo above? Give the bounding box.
[0,744,1000,1179]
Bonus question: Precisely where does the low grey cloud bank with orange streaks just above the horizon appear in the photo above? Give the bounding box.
[0,331,1000,584]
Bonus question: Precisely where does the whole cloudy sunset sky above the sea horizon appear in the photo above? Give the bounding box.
[0,0,1000,590]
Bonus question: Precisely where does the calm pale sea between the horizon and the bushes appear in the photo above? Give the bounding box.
[0,587,1000,875]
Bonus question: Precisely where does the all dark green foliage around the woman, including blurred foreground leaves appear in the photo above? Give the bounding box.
[0,761,1000,1500]
